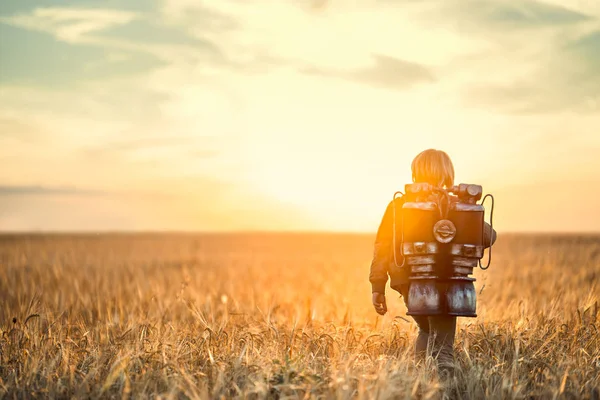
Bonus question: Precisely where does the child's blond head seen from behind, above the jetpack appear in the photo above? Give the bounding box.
[411,149,454,188]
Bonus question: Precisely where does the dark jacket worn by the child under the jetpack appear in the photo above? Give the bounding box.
[369,198,496,293]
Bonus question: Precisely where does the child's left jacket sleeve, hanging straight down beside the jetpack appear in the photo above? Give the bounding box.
[369,202,393,294]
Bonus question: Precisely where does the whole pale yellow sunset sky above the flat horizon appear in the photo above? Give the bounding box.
[0,0,600,232]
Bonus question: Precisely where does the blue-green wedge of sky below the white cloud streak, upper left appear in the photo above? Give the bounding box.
[0,24,161,86]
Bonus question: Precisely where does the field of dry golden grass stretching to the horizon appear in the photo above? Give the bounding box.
[0,235,600,399]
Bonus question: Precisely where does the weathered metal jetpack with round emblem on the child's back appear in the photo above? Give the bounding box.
[392,183,494,317]
